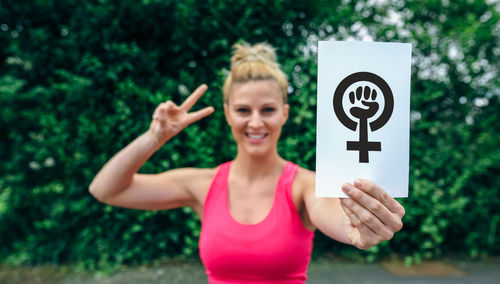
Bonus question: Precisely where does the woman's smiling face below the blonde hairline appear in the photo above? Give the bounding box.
[224,80,290,156]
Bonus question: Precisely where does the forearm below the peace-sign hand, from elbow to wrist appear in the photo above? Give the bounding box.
[89,131,159,201]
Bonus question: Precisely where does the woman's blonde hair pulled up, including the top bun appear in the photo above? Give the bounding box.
[222,42,288,103]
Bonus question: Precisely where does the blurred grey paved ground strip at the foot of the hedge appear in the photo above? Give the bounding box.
[0,259,500,284]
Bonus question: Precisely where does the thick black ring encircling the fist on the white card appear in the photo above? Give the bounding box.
[333,72,394,131]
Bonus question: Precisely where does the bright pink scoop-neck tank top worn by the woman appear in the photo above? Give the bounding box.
[200,162,314,284]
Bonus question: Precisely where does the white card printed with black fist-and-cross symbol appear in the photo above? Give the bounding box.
[316,41,411,197]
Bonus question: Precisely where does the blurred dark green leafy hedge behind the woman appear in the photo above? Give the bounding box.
[0,0,500,268]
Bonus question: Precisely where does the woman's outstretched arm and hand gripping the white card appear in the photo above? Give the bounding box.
[304,176,405,249]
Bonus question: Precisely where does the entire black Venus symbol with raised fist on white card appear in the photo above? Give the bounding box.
[333,72,394,163]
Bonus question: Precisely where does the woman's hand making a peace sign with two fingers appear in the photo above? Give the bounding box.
[149,84,214,147]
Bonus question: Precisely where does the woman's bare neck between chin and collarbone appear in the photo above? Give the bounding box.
[232,153,286,180]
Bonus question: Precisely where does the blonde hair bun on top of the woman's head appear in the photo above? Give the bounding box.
[231,42,279,68]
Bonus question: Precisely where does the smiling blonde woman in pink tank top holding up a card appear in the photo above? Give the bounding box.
[90,41,404,283]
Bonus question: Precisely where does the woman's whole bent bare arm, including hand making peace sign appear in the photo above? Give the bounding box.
[89,85,214,210]
